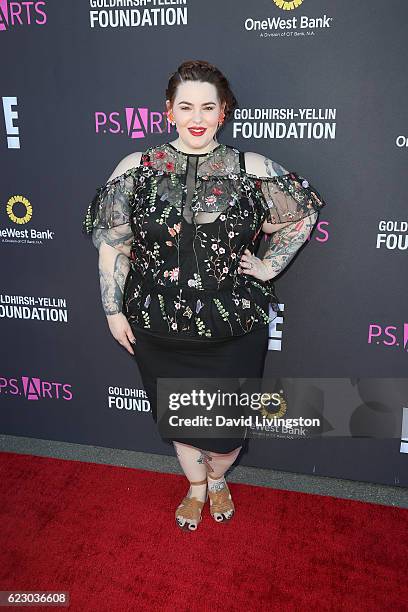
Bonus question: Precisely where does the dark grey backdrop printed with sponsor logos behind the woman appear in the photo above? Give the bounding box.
[0,0,408,486]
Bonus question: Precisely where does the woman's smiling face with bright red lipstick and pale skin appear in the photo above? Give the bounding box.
[166,81,225,149]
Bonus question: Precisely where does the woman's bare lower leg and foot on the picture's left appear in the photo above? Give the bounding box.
[173,441,207,525]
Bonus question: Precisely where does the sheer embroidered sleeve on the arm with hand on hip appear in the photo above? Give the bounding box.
[255,172,326,224]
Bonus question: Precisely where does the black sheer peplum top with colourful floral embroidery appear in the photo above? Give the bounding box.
[83,143,325,341]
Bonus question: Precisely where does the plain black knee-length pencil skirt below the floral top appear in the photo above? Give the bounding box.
[133,325,269,453]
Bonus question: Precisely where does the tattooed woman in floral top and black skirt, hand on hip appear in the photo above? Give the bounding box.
[83,61,324,530]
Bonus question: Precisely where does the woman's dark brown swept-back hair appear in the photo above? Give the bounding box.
[166,60,238,122]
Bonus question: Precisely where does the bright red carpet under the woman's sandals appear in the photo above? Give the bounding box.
[0,453,408,612]
